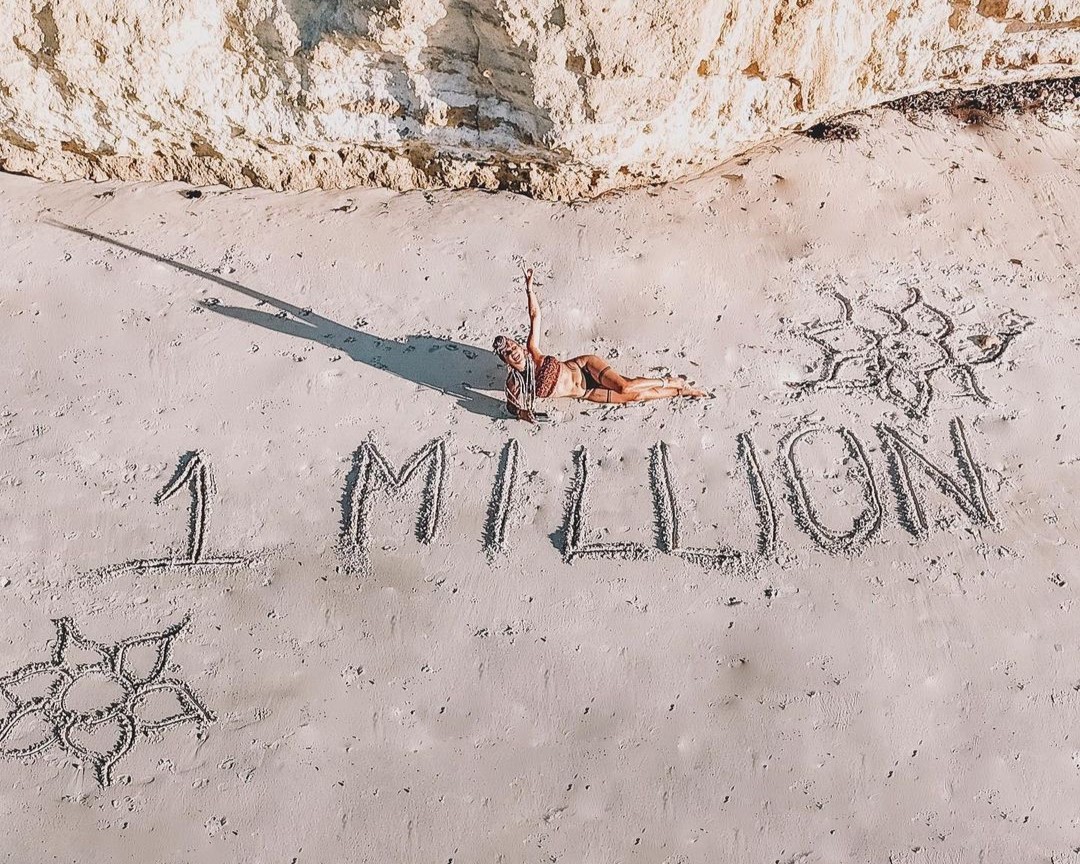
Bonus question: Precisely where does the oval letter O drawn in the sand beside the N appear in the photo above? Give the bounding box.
[782,426,883,554]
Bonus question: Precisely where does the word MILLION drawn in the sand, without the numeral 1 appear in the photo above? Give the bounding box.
[341,418,995,572]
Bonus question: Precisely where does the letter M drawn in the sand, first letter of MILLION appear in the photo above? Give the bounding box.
[341,437,447,572]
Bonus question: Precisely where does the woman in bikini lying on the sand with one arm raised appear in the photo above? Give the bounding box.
[495,270,708,422]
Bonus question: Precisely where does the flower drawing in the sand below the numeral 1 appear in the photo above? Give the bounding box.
[0,618,214,786]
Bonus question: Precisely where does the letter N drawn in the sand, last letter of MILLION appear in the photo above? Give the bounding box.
[877,417,995,537]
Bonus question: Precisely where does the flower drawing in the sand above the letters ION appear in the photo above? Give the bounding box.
[791,287,1030,419]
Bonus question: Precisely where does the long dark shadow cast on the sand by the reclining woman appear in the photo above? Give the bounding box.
[45,219,508,418]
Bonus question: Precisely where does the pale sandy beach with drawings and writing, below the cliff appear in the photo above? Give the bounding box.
[0,112,1080,864]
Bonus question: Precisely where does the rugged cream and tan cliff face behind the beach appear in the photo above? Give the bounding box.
[0,0,1080,199]
